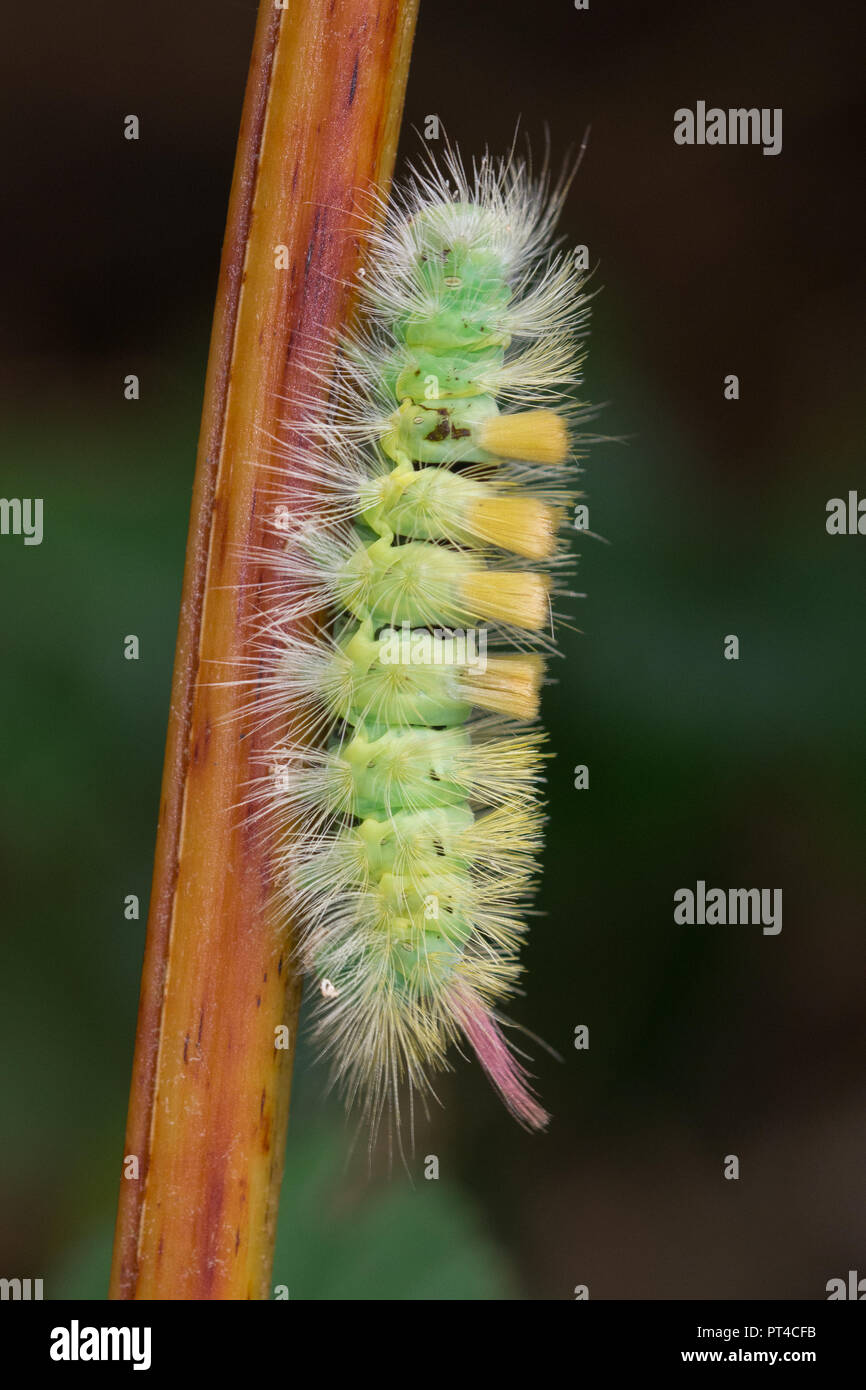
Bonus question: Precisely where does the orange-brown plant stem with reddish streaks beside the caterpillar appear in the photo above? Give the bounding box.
[110,0,417,1298]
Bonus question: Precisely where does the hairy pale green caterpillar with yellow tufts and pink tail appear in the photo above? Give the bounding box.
[247,147,588,1130]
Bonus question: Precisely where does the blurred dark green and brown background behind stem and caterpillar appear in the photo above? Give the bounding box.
[0,0,866,1298]
